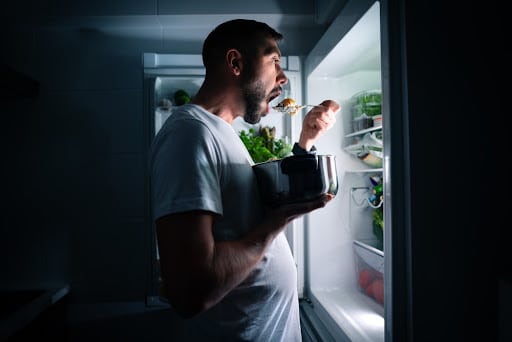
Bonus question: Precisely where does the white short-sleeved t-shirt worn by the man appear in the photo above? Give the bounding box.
[150,104,301,342]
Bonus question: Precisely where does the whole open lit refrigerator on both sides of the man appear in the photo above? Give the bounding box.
[144,0,407,342]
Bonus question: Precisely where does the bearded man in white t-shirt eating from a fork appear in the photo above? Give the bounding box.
[151,19,340,342]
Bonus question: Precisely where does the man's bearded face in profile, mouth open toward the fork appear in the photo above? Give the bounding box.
[241,40,288,124]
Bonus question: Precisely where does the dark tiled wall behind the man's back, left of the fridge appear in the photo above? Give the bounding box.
[0,20,161,301]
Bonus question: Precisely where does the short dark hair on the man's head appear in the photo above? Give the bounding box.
[203,19,283,70]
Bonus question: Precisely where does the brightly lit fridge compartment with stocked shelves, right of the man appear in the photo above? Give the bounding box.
[301,1,392,341]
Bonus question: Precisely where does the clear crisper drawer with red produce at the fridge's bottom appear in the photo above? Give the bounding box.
[354,240,384,305]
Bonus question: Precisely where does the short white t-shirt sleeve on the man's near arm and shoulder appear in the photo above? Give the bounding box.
[150,120,222,220]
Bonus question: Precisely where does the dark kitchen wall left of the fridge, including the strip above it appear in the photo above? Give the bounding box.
[0,0,334,304]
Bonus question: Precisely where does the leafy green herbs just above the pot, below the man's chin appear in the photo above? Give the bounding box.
[240,126,292,163]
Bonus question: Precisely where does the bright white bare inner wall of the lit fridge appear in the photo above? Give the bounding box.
[304,2,384,341]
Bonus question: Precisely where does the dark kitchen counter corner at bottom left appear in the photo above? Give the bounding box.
[0,285,69,341]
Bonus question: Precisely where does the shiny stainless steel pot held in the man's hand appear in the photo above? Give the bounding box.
[253,154,338,206]
